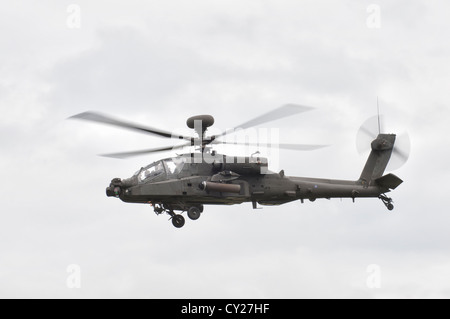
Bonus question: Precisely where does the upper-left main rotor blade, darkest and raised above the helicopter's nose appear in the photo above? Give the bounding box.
[69,112,191,141]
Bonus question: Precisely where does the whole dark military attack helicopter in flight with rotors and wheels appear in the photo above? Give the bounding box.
[70,104,408,228]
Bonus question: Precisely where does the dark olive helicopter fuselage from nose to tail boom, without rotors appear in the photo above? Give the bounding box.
[106,153,389,212]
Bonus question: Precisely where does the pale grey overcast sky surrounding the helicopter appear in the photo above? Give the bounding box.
[0,0,450,298]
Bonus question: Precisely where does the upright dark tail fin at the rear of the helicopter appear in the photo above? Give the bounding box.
[359,134,395,186]
